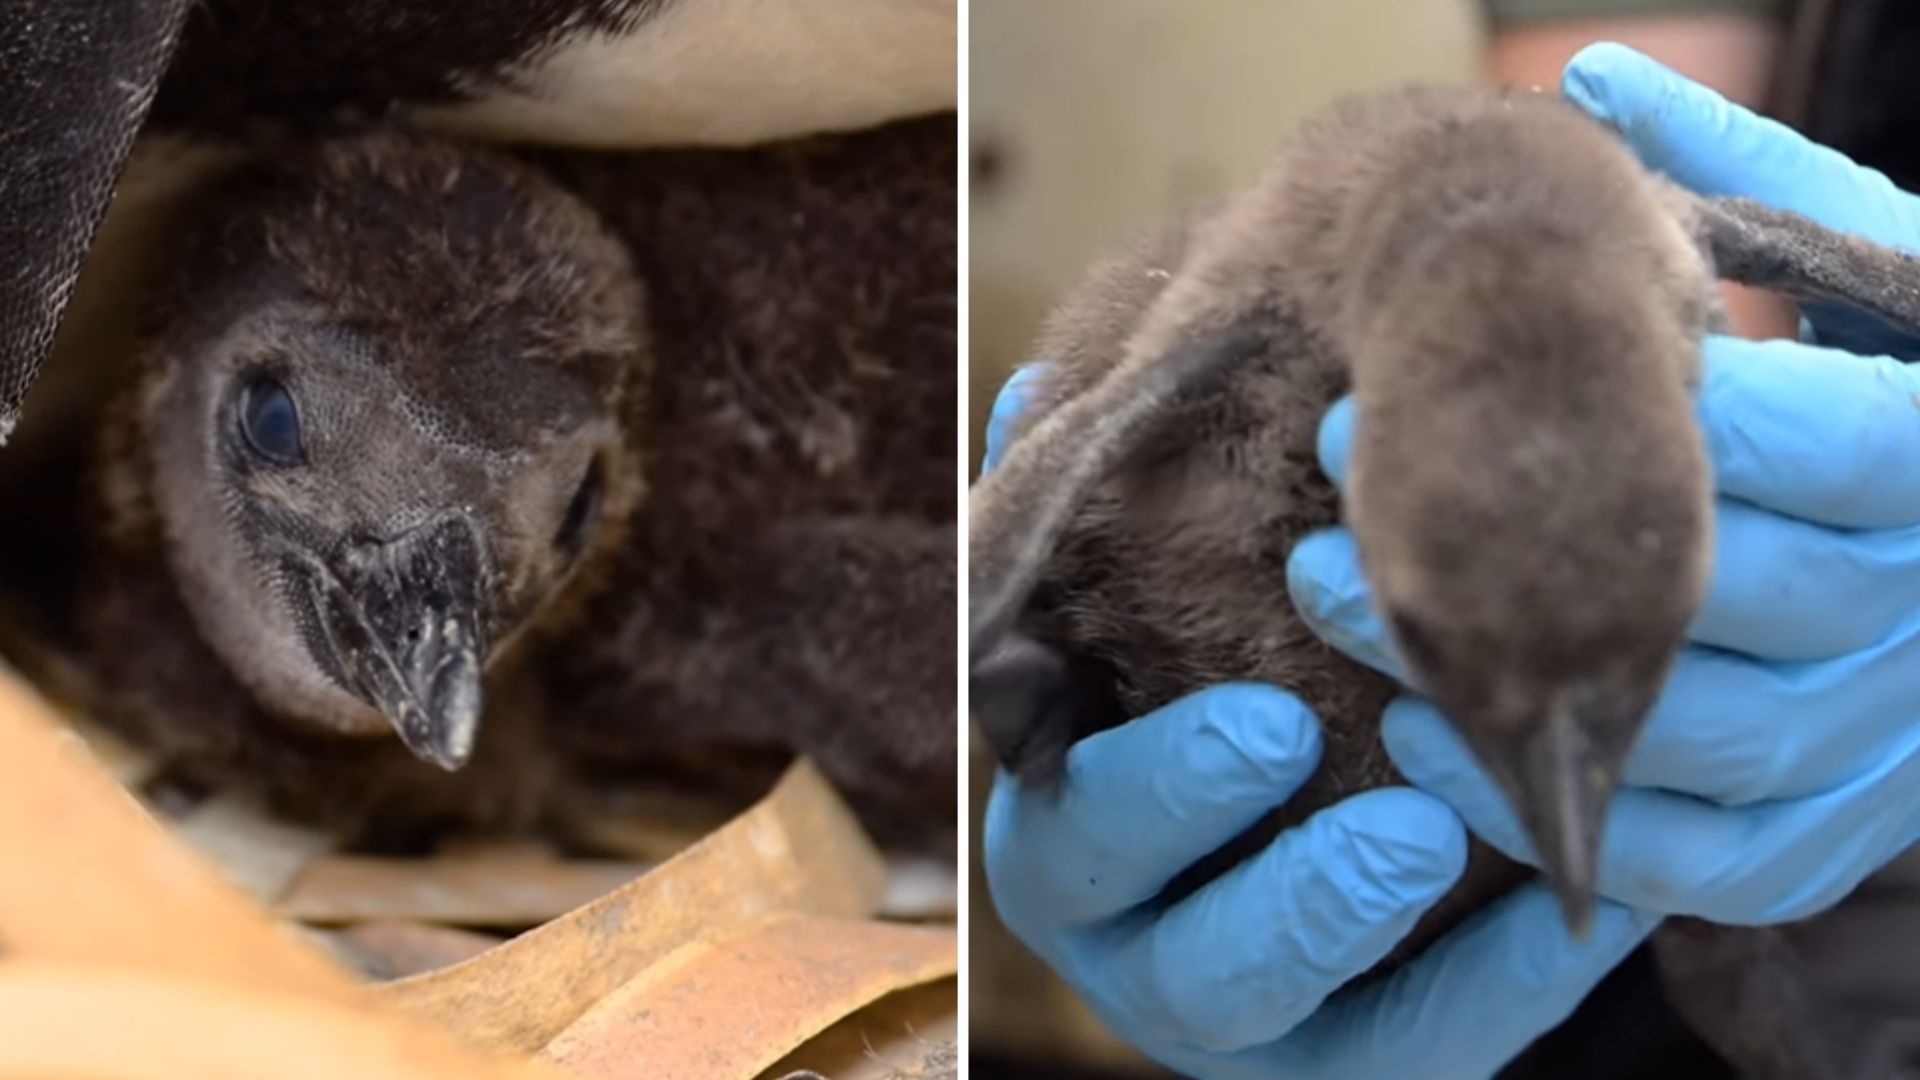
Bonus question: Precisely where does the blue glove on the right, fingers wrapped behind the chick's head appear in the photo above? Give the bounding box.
[1290,46,1920,924]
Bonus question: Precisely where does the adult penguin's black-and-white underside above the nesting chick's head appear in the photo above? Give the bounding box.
[154,0,958,150]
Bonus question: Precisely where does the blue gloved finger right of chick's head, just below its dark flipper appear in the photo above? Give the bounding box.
[1697,336,1920,528]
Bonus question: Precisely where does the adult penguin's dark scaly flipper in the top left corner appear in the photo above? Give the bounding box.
[0,0,188,444]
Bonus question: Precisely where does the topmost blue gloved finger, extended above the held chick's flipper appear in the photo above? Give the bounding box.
[1561,42,1920,248]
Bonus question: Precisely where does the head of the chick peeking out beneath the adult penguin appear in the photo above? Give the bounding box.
[129,136,643,769]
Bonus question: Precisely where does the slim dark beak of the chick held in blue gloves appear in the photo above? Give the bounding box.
[1480,709,1624,938]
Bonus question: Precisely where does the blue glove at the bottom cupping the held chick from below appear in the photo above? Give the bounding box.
[985,365,1655,1080]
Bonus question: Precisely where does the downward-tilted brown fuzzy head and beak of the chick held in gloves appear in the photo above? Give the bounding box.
[1346,228,1711,930]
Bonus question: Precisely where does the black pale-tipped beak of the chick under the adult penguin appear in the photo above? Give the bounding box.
[313,517,488,773]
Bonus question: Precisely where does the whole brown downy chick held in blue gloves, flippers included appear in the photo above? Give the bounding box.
[970,90,1920,1076]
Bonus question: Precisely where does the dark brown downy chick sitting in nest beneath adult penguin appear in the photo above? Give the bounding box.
[79,117,956,840]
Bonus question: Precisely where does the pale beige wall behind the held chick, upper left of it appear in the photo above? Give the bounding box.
[968,0,1482,468]
